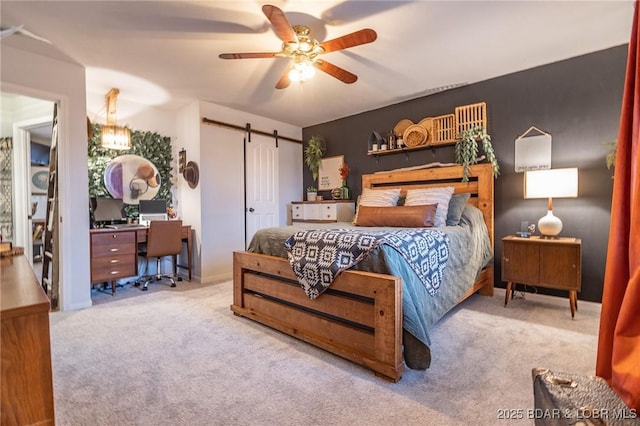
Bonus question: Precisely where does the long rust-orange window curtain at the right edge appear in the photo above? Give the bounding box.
[596,0,640,410]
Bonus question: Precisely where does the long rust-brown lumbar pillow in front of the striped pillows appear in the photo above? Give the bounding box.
[356,204,438,228]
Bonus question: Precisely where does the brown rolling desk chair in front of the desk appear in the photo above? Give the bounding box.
[136,220,182,291]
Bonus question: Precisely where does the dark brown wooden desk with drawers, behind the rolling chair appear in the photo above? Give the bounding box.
[89,225,193,294]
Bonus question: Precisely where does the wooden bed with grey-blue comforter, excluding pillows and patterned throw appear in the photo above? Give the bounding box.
[231,164,494,381]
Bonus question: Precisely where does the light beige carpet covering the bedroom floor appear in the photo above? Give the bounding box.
[51,282,600,426]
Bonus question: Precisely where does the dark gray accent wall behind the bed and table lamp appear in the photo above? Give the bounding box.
[303,45,628,303]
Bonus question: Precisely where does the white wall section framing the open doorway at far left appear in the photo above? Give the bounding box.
[0,45,91,310]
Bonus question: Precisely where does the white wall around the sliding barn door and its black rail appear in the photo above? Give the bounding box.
[177,102,302,282]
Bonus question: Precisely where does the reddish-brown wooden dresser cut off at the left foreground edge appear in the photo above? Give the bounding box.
[0,256,55,425]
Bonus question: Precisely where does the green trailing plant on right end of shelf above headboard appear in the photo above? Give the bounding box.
[456,126,500,182]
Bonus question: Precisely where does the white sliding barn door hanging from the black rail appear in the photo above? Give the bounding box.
[245,134,279,247]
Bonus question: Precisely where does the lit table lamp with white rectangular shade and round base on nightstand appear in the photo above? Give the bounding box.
[524,168,578,238]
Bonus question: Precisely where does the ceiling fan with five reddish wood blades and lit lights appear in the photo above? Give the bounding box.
[219,4,378,89]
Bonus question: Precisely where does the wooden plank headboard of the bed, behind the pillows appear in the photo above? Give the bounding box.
[362,163,494,248]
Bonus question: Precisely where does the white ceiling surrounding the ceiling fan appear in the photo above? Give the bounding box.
[0,0,633,127]
